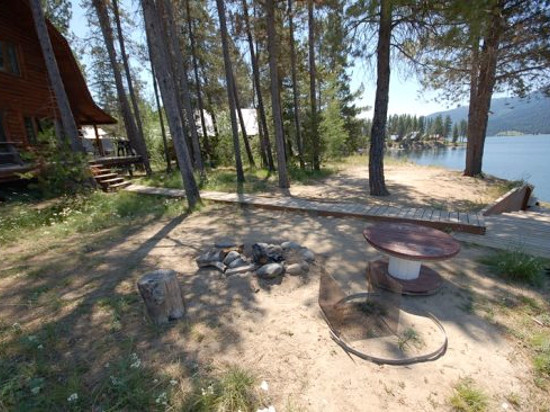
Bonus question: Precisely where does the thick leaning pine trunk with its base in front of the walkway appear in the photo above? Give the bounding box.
[141,0,201,208]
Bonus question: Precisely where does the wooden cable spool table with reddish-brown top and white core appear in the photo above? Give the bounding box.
[363,223,460,295]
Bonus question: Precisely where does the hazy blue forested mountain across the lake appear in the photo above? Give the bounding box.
[426,93,550,136]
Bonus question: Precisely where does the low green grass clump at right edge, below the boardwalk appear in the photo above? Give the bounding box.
[480,246,544,284]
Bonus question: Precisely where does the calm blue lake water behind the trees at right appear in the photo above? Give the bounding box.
[389,135,550,202]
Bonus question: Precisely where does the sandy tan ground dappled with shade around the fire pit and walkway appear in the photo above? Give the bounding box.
[0,166,550,411]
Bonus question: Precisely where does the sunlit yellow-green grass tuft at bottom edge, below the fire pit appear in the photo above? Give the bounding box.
[183,367,259,412]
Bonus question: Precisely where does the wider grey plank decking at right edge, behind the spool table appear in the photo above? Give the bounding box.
[455,212,550,259]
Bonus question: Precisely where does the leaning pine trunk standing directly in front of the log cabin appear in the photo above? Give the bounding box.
[29,0,84,152]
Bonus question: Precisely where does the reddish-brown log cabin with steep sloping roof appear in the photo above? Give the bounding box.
[0,0,116,182]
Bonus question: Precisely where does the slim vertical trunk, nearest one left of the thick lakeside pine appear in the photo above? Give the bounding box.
[307,0,321,170]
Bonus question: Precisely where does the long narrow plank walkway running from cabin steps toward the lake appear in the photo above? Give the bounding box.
[125,185,485,234]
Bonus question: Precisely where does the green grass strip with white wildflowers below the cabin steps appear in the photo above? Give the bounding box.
[0,191,186,244]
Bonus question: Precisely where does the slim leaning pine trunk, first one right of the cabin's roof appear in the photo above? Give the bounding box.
[92,0,151,173]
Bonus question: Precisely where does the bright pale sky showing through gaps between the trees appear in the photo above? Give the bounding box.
[71,0,458,118]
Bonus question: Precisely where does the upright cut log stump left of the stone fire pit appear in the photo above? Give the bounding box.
[137,269,185,325]
